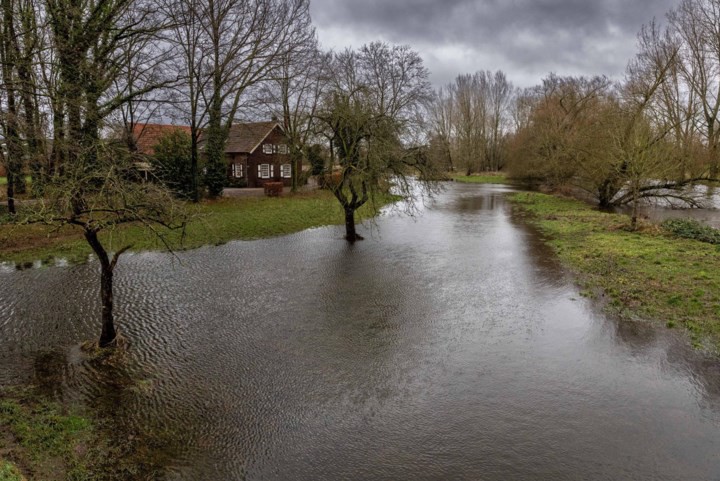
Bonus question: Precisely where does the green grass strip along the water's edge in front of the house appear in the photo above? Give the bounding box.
[0,191,394,263]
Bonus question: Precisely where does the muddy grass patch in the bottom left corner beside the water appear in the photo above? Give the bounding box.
[0,378,177,481]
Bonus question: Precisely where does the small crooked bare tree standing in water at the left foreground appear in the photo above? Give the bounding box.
[27,142,185,347]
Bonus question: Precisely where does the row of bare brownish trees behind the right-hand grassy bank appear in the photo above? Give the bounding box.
[428,0,720,221]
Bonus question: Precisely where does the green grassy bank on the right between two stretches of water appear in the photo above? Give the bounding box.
[511,193,720,352]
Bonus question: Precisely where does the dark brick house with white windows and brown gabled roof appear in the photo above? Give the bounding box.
[225,122,294,187]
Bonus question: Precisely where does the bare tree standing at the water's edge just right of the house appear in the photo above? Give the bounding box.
[317,42,435,242]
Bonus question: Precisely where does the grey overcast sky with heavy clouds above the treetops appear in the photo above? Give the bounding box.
[311,0,679,87]
